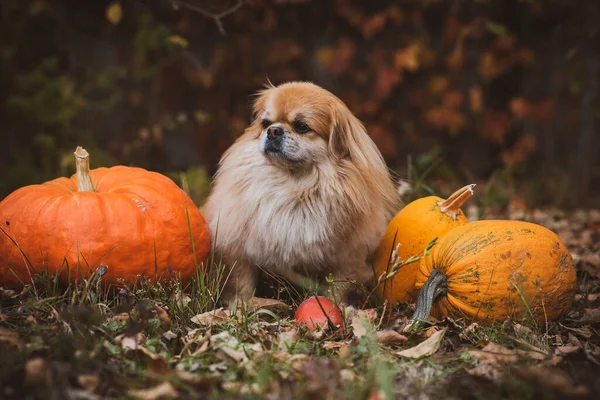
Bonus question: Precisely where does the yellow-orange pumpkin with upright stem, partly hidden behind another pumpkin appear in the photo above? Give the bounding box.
[374,185,475,304]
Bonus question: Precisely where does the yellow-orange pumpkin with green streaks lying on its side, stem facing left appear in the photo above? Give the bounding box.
[412,220,576,323]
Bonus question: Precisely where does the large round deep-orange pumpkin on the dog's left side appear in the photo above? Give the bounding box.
[0,147,210,287]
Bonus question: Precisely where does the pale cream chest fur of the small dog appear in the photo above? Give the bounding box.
[221,166,341,270]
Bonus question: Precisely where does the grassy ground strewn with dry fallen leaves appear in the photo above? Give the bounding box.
[0,205,600,400]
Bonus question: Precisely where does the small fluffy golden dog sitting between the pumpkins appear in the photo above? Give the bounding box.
[203,82,399,302]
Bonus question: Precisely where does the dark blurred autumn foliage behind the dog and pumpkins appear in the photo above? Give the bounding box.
[0,0,600,206]
